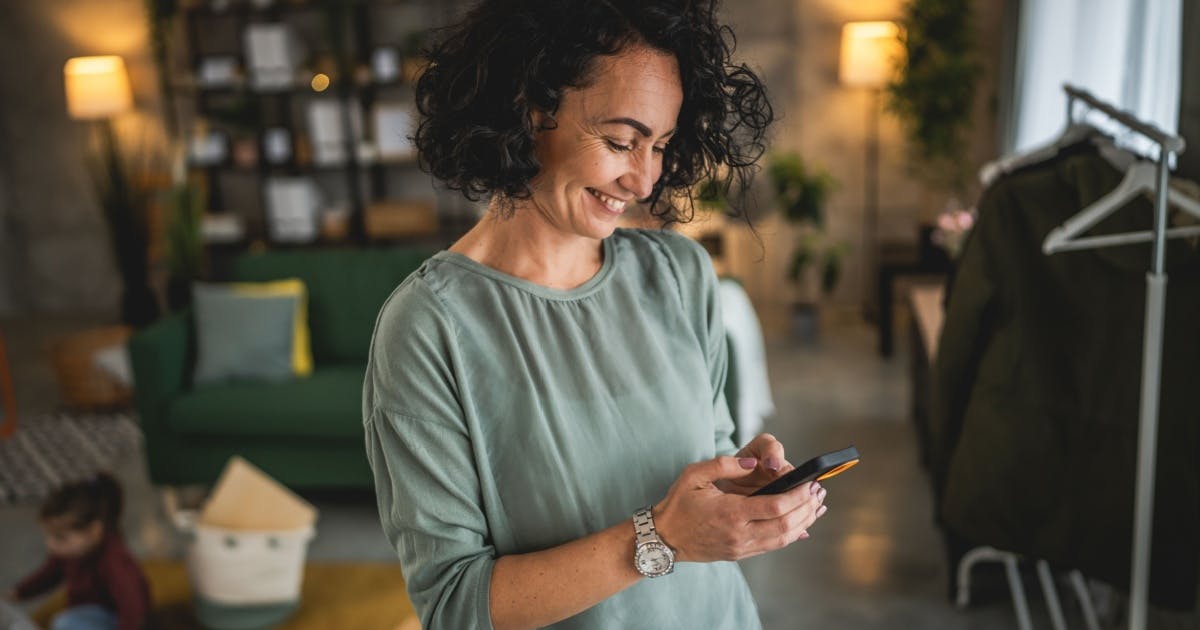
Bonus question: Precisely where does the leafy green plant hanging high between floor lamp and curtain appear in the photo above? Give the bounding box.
[888,0,982,194]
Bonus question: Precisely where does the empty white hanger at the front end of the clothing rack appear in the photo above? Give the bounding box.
[1042,161,1200,254]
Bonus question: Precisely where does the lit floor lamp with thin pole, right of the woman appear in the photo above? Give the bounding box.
[838,22,902,316]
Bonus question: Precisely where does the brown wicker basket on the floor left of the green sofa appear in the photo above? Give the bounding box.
[52,326,133,409]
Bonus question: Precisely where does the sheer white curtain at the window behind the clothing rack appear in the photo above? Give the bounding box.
[1003,0,1182,154]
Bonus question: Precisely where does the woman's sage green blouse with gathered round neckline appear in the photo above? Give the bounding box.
[362,229,760,630]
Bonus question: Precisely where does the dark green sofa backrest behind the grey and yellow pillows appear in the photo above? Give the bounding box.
[233,247,432,365]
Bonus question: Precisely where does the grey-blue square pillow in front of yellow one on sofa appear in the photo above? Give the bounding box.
[192,283,298,385]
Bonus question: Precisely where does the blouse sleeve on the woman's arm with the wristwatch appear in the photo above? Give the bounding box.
[362,278,496,630]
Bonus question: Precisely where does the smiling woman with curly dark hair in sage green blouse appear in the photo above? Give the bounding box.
[364,0,824,630]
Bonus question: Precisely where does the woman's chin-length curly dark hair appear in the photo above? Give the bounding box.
[413,0,774,224]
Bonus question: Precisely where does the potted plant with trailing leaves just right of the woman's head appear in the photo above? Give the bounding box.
[767,152,850,341]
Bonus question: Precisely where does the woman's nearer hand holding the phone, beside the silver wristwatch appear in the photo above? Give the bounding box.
[654,453,826,562]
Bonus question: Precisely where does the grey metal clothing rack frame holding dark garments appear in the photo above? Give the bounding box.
[1055,84,1187,630]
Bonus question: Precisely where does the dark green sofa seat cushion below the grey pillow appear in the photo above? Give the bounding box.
[167,365,366,439]
